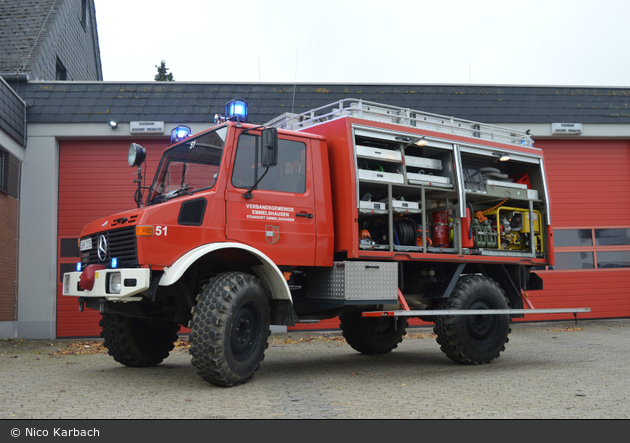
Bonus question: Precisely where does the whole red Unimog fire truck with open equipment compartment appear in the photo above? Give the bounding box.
[63,99,590,386]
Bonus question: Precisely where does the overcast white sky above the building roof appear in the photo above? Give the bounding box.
[95,0,630,87]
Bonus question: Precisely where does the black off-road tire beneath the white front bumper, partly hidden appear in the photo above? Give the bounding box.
[99,314,179,368]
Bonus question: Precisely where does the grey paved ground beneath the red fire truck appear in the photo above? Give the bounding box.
[0,319,630,420]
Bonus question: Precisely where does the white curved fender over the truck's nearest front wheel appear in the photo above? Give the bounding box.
[158,242,293,303]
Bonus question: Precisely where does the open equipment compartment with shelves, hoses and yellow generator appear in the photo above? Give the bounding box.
[354,121,548,257]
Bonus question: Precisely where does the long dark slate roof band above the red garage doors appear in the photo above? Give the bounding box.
[19,82,630,124]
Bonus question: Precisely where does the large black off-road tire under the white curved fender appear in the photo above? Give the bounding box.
[189,272,269,387]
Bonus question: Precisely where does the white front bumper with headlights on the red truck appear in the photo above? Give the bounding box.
[63,268,151,301]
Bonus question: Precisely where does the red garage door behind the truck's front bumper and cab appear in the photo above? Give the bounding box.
[57,139,168,337]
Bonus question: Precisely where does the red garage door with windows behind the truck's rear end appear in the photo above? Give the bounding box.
[527,140,630,320]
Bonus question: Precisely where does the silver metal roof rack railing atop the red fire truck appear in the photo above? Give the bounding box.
[265,98,533,148]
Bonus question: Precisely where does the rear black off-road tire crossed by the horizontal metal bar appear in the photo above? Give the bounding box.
[433,275,511,365]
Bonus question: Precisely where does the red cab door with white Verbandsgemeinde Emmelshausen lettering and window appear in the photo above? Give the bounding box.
[226,131,317,266]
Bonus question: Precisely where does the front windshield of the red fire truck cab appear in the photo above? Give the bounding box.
[147,126,228,205]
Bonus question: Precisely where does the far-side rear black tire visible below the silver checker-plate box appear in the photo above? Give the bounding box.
[339,310,408,354]
